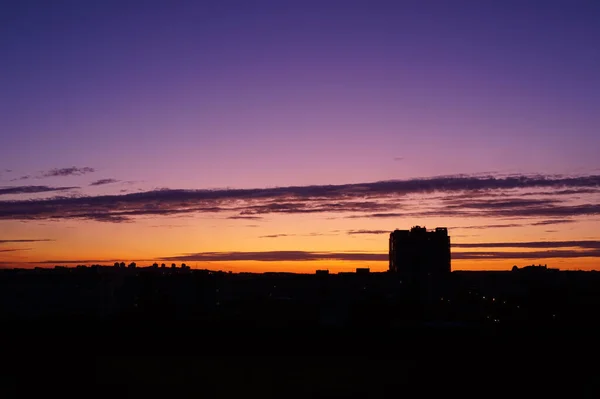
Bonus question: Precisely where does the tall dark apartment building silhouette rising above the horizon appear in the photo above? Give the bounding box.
[389,226,451,274]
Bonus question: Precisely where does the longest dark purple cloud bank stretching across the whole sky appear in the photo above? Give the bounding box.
[0,176,600,222]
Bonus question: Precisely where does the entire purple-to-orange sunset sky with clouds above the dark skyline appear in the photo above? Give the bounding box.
[0,0,600,273]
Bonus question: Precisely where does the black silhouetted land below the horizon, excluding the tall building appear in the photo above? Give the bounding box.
[0,268,600,399]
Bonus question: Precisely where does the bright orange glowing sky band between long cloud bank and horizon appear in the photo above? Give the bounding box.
[0,215,600,273]
